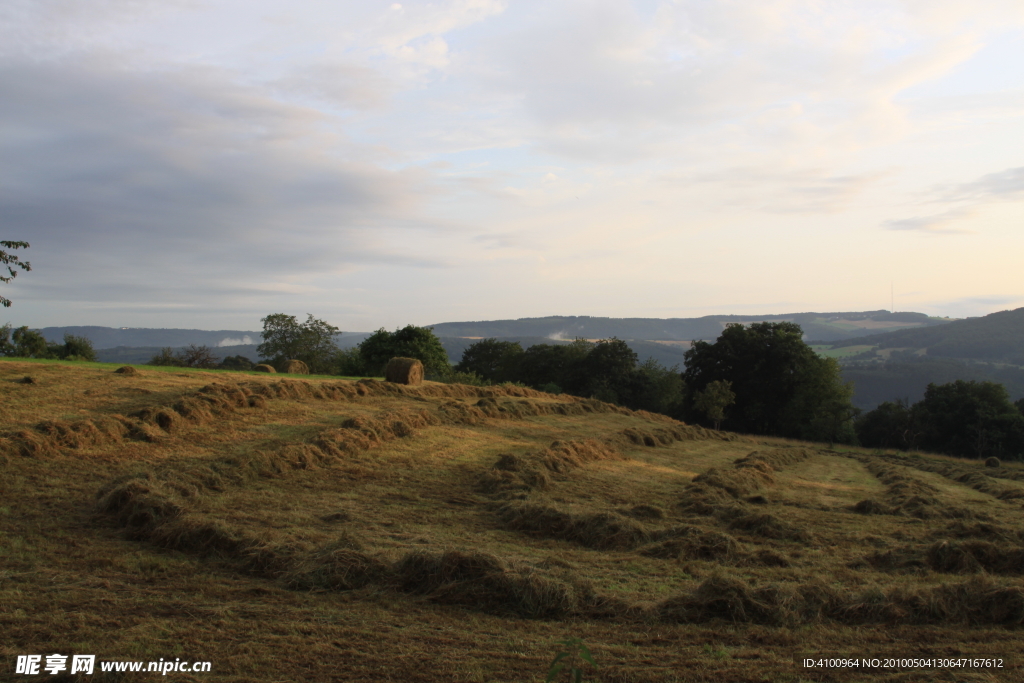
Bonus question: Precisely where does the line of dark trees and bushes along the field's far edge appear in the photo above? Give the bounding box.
[6,313,1024,458]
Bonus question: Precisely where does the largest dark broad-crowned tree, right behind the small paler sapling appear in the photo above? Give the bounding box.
[683,323,854,440]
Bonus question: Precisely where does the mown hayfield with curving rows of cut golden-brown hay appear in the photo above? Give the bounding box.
[0,360,1024,683]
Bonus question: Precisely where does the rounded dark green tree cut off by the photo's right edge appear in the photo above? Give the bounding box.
[912,380,1024,458]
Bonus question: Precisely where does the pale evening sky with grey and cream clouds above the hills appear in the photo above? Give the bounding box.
[0,0,1024,331]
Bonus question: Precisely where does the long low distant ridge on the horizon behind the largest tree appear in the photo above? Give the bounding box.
[429,310,949,342]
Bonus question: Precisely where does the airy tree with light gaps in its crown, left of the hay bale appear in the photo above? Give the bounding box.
[256,313,340,375]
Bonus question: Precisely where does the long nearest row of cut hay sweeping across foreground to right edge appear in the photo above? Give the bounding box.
[99,481,1024,626]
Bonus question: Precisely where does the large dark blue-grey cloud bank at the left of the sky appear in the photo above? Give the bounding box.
[0,60,444,309]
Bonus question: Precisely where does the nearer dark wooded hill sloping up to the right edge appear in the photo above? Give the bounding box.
[833,308,1024,366]
